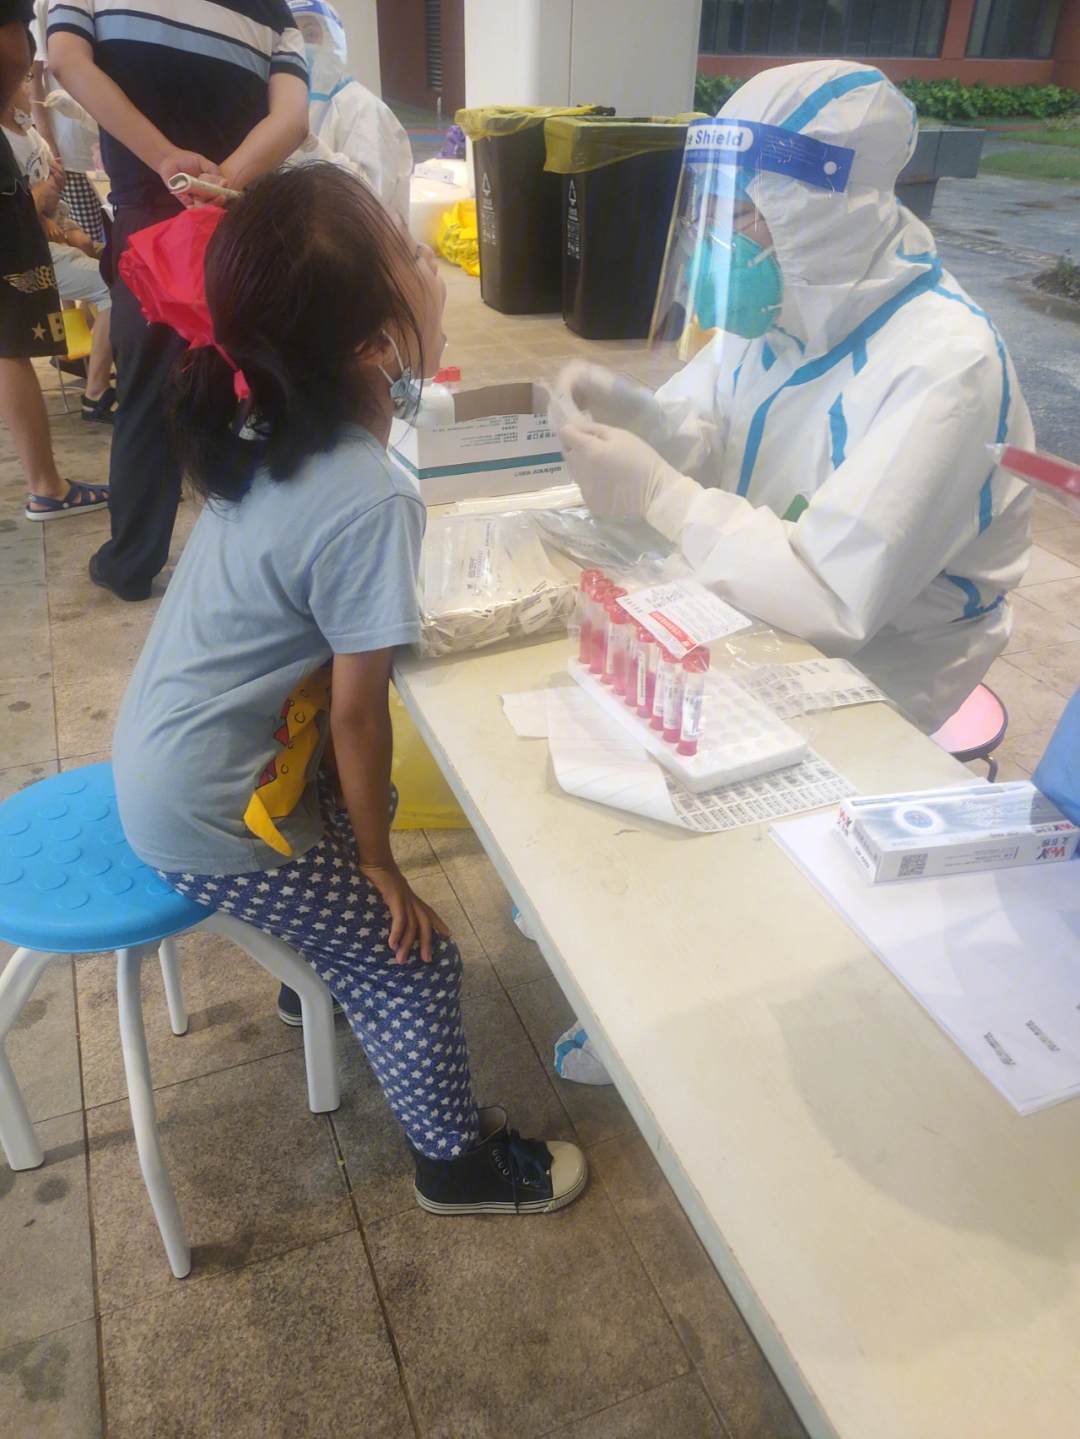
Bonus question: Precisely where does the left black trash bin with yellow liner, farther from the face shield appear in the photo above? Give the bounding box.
[456,105,609,315]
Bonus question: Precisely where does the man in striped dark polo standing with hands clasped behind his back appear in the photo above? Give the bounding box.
[49,0,308,600]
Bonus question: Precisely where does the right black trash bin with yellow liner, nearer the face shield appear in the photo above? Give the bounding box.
[544,115,690,340]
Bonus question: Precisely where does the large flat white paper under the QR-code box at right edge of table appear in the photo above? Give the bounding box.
[772,813,1080,1114]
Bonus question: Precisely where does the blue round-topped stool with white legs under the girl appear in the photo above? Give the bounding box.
[0,764,339,1279]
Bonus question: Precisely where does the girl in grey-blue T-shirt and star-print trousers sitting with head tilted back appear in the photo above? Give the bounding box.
[114,164,587,1215]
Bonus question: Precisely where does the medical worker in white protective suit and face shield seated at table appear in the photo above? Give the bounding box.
[561,60,1033,731]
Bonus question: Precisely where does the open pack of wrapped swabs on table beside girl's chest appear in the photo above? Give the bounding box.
[418,511,575,656]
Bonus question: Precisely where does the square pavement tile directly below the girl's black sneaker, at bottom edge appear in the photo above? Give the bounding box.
[367,1186,690,1439]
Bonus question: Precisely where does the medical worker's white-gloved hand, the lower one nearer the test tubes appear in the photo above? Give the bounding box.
[559,419,683,518]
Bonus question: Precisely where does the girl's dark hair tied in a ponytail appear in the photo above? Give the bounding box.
[170,164,423,501]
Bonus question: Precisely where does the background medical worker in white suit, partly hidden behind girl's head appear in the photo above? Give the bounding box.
[289,0,413,224]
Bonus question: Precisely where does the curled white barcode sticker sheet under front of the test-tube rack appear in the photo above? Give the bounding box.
[549,685,853,835]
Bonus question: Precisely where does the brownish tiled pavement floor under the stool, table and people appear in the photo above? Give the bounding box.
[0,259,1080,1439]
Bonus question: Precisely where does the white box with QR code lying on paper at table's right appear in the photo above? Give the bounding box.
[836,781,1080,885]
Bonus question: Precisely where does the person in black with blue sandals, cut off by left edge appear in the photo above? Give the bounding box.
[0,0,108,519]
